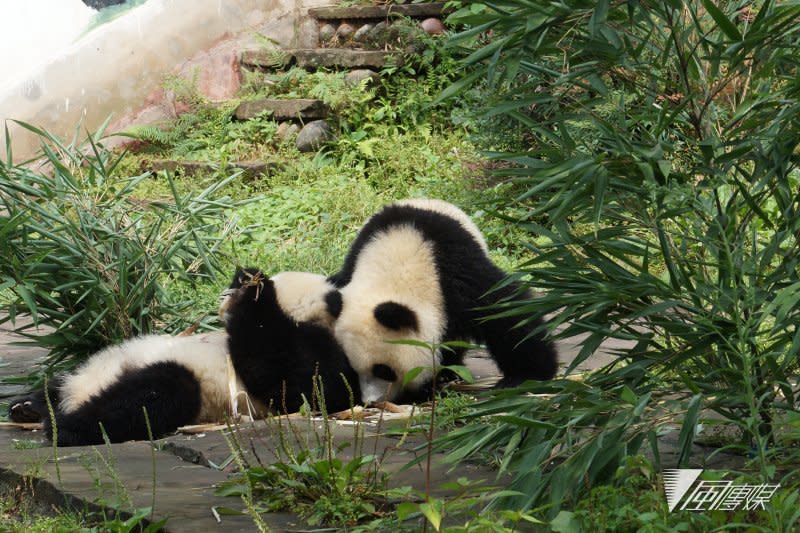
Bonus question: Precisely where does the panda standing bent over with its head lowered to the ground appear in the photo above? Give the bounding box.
[325,199,557,402]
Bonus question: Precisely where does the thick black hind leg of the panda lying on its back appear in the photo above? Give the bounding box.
[44,362,201,446]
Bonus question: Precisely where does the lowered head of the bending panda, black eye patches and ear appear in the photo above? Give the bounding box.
[325,287,439,403]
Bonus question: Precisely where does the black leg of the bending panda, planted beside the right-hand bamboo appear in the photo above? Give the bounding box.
[477,286,558,388]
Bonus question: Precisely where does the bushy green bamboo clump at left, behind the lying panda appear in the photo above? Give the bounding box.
[0,120,244,369]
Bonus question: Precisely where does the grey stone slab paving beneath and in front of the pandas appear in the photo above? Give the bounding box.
[0,316,744,533]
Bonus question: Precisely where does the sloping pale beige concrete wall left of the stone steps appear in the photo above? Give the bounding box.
[0,0,330,161]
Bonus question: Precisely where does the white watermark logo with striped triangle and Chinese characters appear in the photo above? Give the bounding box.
[664,468,781,511]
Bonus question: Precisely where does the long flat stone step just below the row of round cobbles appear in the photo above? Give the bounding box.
[241,48,401,69]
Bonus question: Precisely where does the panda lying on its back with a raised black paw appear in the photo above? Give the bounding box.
[9,270,360,446]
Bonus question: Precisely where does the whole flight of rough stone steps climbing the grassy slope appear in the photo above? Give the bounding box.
[149,2,445,177]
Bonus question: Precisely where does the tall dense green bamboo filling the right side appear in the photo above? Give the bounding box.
[443,0,800,514]
